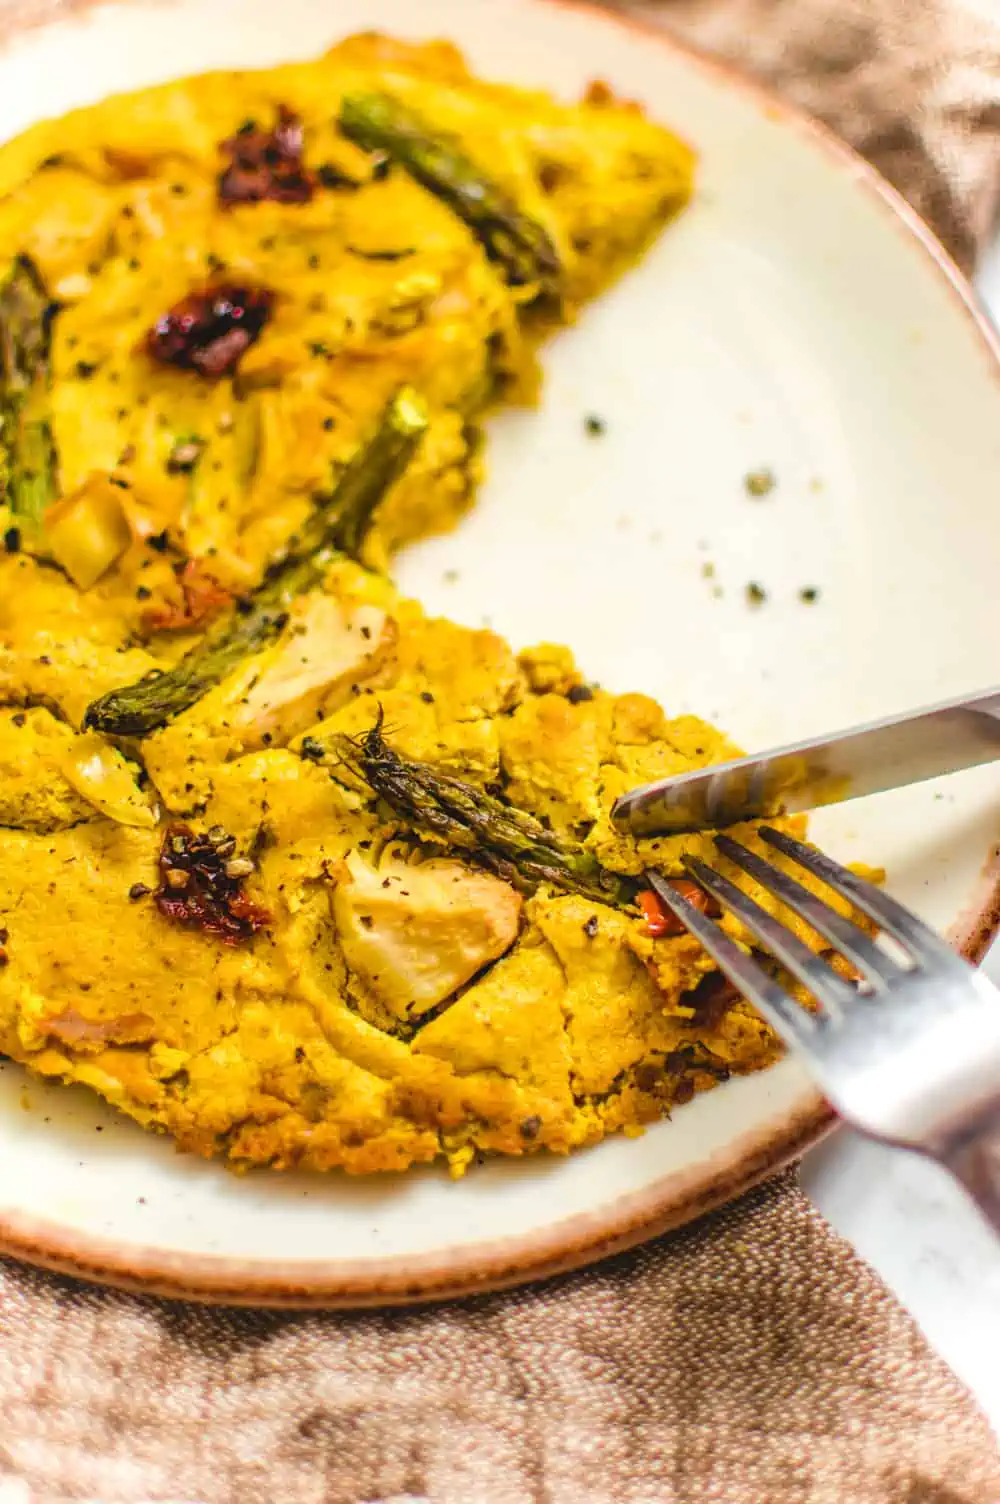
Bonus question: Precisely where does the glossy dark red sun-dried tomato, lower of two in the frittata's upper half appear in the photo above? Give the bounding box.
[146,283,274,376]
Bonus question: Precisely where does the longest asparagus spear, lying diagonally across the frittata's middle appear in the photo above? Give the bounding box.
[84,387,427,737]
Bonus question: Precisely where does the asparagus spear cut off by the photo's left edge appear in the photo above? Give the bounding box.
[0,256,56,531]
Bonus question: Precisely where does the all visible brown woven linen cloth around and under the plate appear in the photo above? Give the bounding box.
[0,0,1000,1504]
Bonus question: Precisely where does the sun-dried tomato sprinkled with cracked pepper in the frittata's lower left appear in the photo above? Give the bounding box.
[155,826,271,945]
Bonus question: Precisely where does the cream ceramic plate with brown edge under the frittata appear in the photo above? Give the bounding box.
[0,0,1000,1304]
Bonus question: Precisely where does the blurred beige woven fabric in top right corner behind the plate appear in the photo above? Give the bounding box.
[617,0,1000,269]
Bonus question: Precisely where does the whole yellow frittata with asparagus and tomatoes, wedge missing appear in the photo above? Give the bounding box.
[0,26,842,1173]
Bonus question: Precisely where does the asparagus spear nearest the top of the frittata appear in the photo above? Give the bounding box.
[340,93,561,293]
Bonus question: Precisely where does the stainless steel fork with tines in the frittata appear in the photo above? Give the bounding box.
[645,827,1000,1230]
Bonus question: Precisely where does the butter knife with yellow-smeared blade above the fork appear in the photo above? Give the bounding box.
[612,689,1000,835]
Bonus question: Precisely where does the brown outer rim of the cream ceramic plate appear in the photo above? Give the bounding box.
[0,0,1000,1308]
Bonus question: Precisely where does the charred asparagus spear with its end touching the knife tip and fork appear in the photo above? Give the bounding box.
[330,714,639,908]
